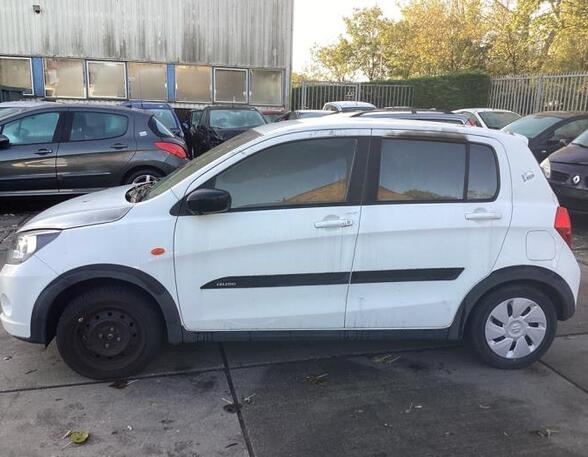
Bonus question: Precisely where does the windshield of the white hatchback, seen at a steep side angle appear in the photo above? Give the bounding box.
[145,130,261,199]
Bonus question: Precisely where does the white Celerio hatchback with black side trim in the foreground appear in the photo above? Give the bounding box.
[0,116,580,379]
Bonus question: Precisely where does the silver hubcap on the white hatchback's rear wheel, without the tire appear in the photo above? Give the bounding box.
[486,298,547,359]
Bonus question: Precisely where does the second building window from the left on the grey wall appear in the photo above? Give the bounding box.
[44,59,86,98]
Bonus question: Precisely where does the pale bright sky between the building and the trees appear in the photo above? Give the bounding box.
[293,0,400,72]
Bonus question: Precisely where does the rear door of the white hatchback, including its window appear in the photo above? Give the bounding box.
[346,132,511,329]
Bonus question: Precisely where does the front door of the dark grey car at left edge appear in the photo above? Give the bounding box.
[0,110,63,194]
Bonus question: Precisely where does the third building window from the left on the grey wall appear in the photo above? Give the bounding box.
[86,61,127,98]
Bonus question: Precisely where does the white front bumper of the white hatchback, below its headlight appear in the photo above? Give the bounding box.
[0,255,57,339]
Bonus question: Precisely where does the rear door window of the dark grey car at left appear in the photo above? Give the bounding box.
[69,111,129,141]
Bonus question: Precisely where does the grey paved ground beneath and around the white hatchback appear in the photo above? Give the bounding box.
[0,199,588,457]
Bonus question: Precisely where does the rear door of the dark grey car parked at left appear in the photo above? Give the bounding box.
[57,109,136,192]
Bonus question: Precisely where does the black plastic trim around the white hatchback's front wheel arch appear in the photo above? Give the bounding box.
[29,264,182,345]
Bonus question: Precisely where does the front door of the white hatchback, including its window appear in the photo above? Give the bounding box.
[174,131,369,330]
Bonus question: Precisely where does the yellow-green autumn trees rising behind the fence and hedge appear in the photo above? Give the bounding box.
[312,0,588,81]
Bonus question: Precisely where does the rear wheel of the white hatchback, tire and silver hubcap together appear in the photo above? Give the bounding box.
[467,285,557,369]
